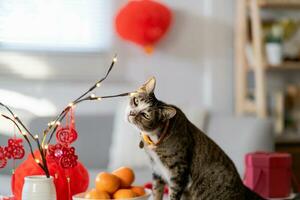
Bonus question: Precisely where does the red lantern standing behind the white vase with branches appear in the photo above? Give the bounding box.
[12,151,89,200]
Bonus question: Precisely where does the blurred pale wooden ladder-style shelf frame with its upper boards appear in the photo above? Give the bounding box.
[235,0,300,118]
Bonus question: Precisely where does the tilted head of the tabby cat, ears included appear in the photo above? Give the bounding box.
[127,78,176,132]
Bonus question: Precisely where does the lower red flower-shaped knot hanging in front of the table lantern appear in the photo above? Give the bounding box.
[48,144,78,169]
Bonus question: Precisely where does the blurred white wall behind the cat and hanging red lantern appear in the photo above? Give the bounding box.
[0,0,234,113]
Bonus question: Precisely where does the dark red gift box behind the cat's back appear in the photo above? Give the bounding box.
[244,152,292,198]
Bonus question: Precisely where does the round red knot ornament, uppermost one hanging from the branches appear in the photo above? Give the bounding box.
[56,126,78,145]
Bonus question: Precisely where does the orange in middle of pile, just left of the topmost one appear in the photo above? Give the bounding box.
[95,172,121,194]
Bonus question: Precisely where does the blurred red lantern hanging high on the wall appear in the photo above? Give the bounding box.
[115,0,172,53]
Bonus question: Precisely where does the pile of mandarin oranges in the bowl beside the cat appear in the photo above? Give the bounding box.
[84,167,145,199]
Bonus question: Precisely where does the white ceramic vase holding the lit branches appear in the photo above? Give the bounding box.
[22,176,56,200]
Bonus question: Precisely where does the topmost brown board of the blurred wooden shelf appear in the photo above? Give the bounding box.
[258,0,300,9]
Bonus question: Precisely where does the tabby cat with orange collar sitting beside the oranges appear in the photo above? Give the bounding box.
[127,78,263,200]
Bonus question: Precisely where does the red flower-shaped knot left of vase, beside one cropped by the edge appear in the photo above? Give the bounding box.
[4,138,25,159]
